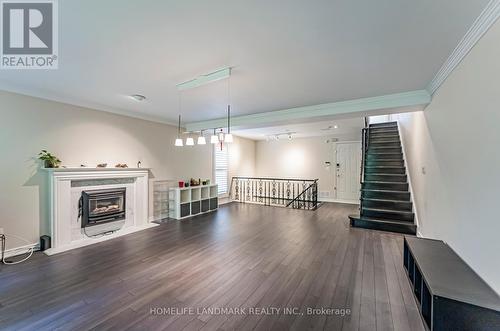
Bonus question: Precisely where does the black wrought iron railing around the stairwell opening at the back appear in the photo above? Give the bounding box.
[229,177,318,210]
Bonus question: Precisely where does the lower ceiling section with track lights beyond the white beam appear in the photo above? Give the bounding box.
[233,118,364,140]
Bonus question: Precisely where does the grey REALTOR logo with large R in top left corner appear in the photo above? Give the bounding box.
[0,0,58,69]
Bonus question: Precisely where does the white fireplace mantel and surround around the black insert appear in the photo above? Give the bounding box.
[44,168,157,255]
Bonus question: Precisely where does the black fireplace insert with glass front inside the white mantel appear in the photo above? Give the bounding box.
[80,187,126,228]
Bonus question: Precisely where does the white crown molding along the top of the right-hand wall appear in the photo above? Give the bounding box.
[426,0,500,95]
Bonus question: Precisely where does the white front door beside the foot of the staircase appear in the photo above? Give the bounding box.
[336,142,361,202]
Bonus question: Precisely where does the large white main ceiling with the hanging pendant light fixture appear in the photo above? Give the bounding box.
[0,0,488,123]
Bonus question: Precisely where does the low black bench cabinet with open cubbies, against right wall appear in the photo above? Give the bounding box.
[403,236,500,331]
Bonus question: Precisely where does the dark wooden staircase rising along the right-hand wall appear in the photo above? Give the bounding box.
[349,122,417,235]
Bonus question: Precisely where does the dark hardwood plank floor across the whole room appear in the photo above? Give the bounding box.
[0,203,423,331]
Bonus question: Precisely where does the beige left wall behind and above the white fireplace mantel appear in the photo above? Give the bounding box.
[0,91,244,249]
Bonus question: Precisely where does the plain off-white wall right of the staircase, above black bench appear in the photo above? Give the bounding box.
[392,21,500,292]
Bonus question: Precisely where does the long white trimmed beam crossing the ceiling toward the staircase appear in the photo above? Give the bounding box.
[186,90,431,131]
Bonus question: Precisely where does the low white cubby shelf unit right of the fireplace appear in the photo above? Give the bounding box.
[169,184,219,220]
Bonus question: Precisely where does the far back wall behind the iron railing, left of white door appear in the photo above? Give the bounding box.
[256,133,361,201]
